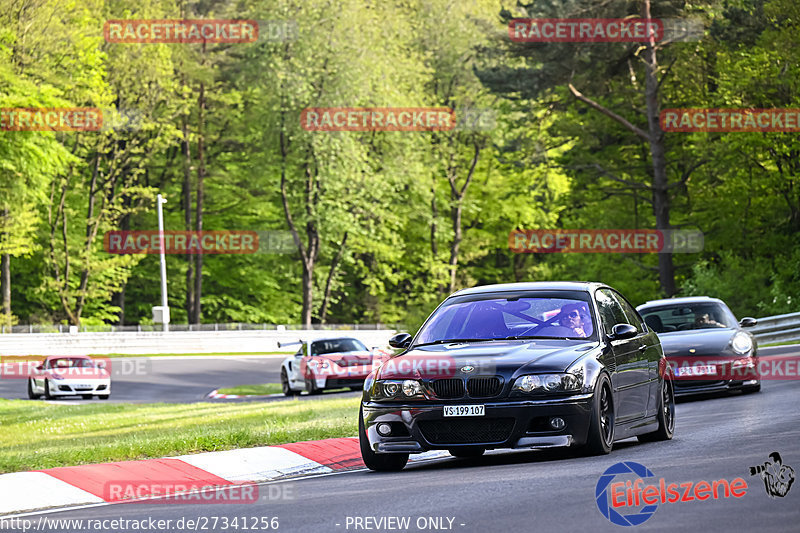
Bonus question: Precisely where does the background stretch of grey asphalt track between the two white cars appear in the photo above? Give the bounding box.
[0,355,355,403]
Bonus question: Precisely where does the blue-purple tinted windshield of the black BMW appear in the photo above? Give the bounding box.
[415,296,595,345]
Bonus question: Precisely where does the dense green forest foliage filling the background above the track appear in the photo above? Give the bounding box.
[0,0,800,328]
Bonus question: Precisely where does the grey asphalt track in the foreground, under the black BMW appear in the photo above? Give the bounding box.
[6,342,800,533]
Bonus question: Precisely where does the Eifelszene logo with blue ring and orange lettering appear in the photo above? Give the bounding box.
[595,461,747,526]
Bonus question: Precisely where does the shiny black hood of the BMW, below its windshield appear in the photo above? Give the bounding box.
[377,339,599,379]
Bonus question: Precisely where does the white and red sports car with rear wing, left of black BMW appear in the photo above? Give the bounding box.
[279,337,382,396]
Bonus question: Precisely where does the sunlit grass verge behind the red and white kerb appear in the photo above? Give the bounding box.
[0,397,360,473]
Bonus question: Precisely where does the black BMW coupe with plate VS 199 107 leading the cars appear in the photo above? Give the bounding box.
[359,282,675,470]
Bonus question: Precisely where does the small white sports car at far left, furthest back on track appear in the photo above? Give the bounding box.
[28,355,111,400]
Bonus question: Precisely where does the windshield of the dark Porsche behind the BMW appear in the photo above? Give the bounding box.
[640,303,736,333]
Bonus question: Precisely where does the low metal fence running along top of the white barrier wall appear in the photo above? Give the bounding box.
[0,322,405,333]
